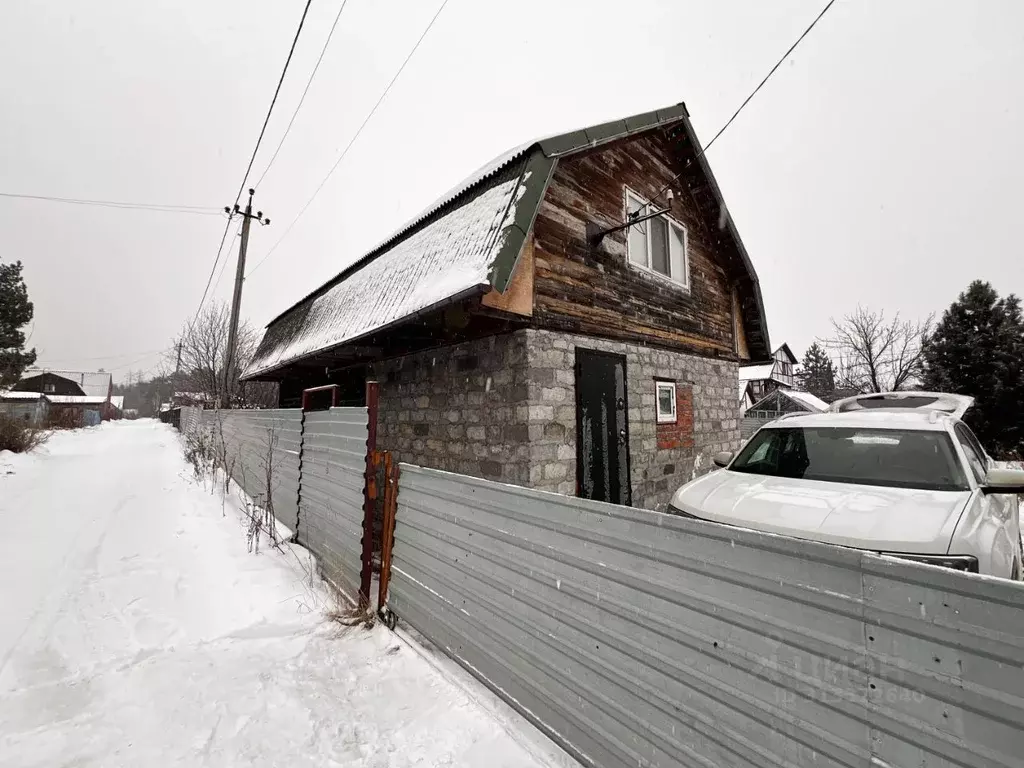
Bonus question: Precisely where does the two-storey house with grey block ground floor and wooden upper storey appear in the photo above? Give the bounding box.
[245,104,771,507]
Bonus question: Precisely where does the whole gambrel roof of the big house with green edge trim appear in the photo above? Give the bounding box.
[245,103,770,379]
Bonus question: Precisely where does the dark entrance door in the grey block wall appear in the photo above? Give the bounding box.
[575,349,630,505]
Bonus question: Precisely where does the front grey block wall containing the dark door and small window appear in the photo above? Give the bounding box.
[521,330,740,510]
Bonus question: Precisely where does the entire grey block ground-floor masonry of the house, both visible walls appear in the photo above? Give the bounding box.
[371,329,740,509]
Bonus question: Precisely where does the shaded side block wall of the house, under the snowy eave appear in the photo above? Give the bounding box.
[370,332,530,485]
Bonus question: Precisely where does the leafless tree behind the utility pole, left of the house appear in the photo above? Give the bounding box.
[167,303,278,408]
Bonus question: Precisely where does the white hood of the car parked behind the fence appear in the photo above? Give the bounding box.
[672,469,971,555]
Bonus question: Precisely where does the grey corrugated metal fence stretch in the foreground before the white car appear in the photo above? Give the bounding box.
[388,465,1024,768]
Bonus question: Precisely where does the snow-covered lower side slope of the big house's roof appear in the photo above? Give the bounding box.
[246,165,529,376]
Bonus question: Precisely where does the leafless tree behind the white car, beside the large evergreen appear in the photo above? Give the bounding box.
[819,306,932,392]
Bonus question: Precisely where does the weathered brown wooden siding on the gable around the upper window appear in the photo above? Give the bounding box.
[534,132,736,359]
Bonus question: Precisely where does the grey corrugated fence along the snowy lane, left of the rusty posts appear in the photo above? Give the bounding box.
[180,408,371,602]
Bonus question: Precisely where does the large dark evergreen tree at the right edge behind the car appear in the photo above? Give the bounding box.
[924,281,1024,459]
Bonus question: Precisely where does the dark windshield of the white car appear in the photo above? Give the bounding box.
[729,427,968,490]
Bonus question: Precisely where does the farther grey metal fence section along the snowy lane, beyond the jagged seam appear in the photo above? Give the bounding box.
[200,409,302,531]
